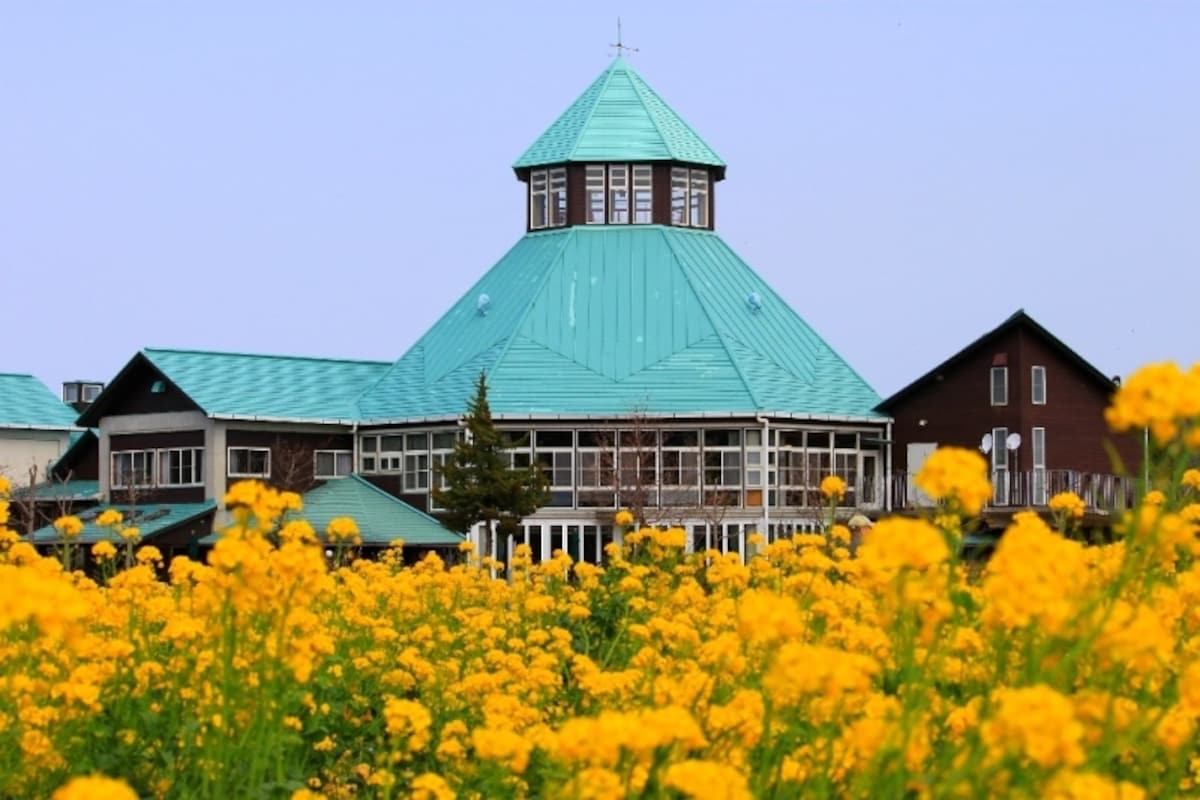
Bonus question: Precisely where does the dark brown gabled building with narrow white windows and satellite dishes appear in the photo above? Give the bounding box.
[877,311,1141,511]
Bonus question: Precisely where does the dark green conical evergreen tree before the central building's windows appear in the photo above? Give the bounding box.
[433,372,546,555]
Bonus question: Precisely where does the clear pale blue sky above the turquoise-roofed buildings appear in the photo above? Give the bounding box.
[0,0,1200,396]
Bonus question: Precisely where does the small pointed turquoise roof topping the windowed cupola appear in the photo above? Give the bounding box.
[512,56,725,169]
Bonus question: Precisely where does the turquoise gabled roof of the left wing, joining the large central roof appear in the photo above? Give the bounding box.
[142,348,391,421]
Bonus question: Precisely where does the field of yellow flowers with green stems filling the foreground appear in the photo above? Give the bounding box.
[0,367,1200,800]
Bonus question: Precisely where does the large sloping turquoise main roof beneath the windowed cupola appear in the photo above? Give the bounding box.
[359,225,884,422]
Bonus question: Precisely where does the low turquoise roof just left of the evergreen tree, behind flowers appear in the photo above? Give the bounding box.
[288,475,463,547]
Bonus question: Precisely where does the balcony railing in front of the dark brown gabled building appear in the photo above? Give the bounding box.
[888,469,1136,511]
